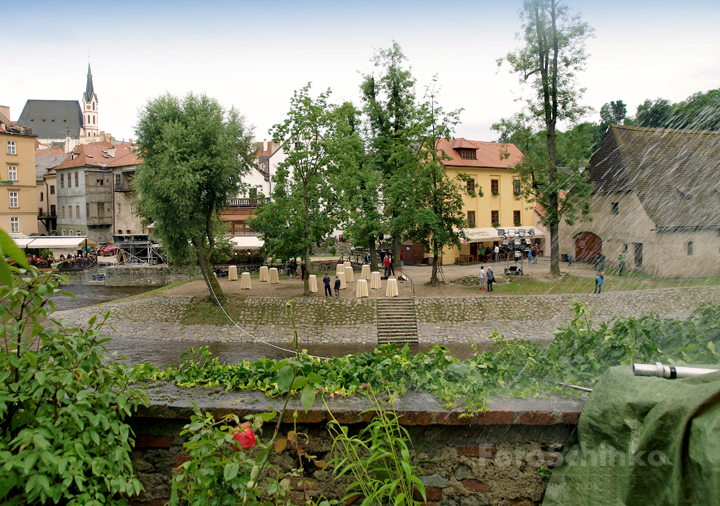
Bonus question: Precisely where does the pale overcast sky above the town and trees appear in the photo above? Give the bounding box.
[0,0,720,141]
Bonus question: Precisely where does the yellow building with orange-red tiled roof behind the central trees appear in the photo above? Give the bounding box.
[438,138,540,264]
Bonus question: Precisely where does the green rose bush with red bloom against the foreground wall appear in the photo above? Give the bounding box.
[170,406,289,506]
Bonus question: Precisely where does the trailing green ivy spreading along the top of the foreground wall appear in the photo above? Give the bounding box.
[139,303,720,412]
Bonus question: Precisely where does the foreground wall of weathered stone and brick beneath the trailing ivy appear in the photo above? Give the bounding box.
[130,385,583,506]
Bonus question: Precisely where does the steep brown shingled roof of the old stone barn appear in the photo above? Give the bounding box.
[589,125,720,229]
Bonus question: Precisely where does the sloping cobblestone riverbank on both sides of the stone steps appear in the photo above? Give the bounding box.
[56,286,720,344]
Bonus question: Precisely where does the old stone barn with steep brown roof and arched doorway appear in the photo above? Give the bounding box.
[560,125,720,278]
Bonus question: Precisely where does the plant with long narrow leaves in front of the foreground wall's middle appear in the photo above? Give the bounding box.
[327,385,426,506]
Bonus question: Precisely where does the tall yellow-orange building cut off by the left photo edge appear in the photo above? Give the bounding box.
[0,108,38,235]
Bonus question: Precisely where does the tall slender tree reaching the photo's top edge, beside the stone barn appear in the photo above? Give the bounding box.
[496,0,592,275]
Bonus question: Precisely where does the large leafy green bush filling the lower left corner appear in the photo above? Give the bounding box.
[0,262,147,505]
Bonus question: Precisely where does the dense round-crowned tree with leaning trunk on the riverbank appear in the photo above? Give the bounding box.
[133,93,257,304]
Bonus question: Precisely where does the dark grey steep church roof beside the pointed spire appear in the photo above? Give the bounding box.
[18,100,82,139]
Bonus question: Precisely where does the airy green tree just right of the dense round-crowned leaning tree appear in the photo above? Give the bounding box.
[251,84,338,295]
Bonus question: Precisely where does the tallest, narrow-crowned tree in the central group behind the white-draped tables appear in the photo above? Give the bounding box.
[361,42,419,272]
